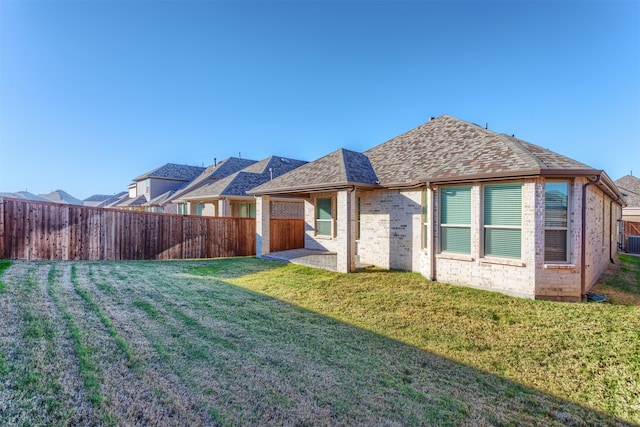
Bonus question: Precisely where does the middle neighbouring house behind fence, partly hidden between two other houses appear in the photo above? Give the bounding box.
[144,157,256,214]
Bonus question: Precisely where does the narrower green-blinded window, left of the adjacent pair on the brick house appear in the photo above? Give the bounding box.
[440,186,471,254]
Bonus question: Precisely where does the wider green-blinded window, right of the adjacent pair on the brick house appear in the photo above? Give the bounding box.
[484,183,522,258]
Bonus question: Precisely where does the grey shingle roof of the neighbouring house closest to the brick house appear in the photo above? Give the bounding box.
[182,156,307,200]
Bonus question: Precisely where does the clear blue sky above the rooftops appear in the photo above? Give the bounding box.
[0,0,640,199]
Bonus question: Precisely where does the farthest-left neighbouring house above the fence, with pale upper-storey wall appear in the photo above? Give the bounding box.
[113,163,205,211]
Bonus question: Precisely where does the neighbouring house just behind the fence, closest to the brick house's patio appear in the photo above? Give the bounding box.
[175,156,307,218]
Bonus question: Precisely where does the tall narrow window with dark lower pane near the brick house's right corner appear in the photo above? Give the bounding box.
[544,182,569,262]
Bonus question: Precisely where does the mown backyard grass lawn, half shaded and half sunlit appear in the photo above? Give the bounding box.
[0,257,640,426]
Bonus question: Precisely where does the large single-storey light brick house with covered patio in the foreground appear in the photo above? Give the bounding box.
[250,115,624,301]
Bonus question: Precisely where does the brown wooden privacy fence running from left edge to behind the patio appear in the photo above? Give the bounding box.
[0,198,304,260]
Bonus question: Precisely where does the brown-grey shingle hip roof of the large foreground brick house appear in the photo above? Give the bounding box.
[251,115,600,194]
